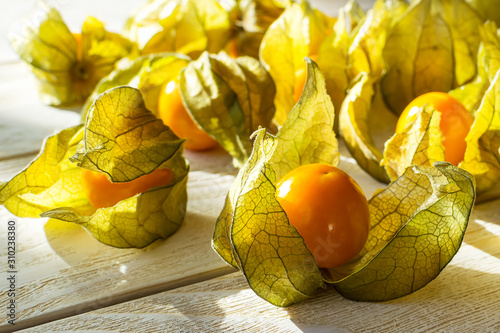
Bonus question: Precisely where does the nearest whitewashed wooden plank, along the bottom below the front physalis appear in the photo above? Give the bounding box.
[22,200,500,333]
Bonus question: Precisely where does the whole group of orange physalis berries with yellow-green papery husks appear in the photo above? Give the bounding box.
[0,0,500,306]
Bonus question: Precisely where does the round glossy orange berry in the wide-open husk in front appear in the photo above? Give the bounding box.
[276,164,370,268]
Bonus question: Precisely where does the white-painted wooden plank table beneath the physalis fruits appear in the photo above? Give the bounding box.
[0,0,500,332]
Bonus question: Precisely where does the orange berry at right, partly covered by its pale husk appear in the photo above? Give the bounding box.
[396,92,474,165]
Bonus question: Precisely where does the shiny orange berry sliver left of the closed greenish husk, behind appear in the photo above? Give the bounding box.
[158,80,218,151]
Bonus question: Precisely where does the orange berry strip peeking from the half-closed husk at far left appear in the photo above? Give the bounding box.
[82,169,174,209]
